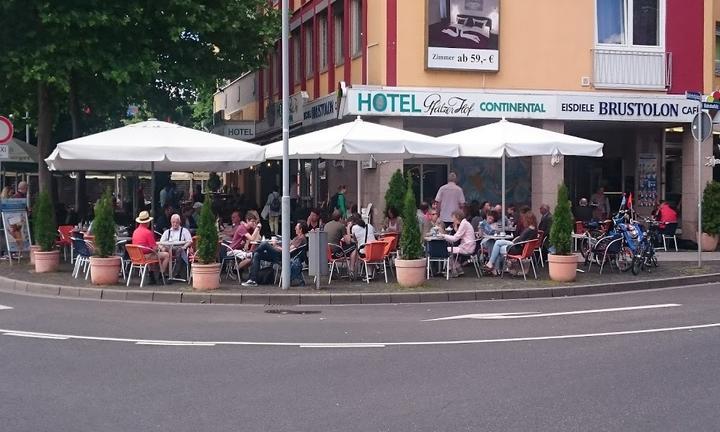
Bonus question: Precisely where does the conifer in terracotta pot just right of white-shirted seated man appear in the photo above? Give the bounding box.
[192,194,220,290]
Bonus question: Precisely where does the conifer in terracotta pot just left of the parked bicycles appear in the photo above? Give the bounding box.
[548,184,577,282]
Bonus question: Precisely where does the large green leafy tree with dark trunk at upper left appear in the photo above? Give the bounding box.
[0,0,280,194]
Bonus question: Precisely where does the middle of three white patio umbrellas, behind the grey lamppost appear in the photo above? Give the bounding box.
[265,117,458,207]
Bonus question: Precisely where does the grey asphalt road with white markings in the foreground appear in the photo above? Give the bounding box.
[0,285,720,432]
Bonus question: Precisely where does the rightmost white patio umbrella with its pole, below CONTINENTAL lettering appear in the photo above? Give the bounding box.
[437,119,603,228]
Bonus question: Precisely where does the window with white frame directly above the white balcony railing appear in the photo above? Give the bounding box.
[595,0,665,47]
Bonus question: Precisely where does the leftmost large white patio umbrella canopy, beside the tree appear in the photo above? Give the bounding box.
[45,120,265,171]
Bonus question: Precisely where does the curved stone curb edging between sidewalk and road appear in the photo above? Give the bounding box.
[0,273,720,305]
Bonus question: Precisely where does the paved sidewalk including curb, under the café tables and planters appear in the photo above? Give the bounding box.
[0,252,720,304]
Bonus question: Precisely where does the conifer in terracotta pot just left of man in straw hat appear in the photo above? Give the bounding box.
[90,190,122,285]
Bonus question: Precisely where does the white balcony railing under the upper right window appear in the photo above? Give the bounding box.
[593,49,672,90]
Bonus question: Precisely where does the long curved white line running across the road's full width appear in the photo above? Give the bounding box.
[0,323,720,348]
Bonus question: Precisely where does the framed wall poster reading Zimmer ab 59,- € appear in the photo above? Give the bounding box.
[425,0,500,71]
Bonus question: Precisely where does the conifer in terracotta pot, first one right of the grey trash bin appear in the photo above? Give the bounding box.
[395,175,425,288]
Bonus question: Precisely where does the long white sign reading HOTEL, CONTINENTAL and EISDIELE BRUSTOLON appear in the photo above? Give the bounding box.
[343,88,697,122]
